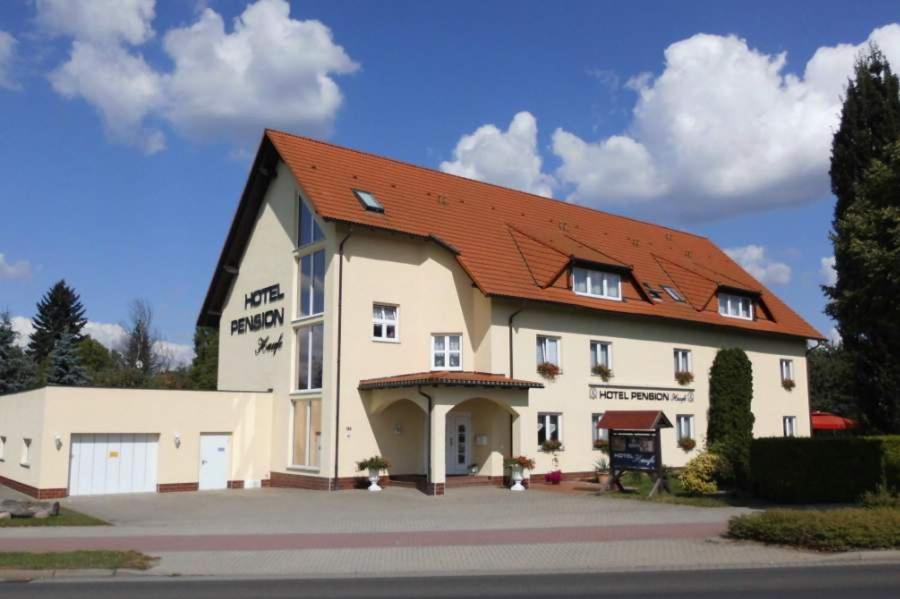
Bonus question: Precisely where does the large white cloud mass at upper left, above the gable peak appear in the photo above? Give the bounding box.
[38,0,359,153]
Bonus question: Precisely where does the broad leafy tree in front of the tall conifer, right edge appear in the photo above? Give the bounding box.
[826,143,900,433]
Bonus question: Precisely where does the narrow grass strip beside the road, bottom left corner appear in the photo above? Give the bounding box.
[0,551,156,570]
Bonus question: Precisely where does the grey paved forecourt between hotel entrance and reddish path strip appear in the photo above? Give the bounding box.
[42,487,746,534]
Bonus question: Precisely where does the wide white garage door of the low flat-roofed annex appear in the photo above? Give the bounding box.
[69,433,159,495]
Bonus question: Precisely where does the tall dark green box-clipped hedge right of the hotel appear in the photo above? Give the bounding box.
[750,436,900,503]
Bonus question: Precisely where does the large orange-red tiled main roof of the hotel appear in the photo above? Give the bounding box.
[200,130,822,338]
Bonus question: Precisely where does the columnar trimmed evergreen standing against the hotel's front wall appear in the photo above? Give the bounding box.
[706,347,754,486]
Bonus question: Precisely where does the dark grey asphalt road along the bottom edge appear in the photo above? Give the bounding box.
[0,565,900,599]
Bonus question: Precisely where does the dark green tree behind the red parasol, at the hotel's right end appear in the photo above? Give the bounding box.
[806,343,858,418]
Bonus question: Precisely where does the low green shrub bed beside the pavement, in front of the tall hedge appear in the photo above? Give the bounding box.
[728,508,900,551]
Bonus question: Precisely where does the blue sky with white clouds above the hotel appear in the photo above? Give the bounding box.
[0,0,900,360]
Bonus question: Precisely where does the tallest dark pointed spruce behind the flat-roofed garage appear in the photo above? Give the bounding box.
[28,280,87,364]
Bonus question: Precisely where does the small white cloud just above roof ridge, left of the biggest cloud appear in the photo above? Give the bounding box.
[440,112,555,196]
